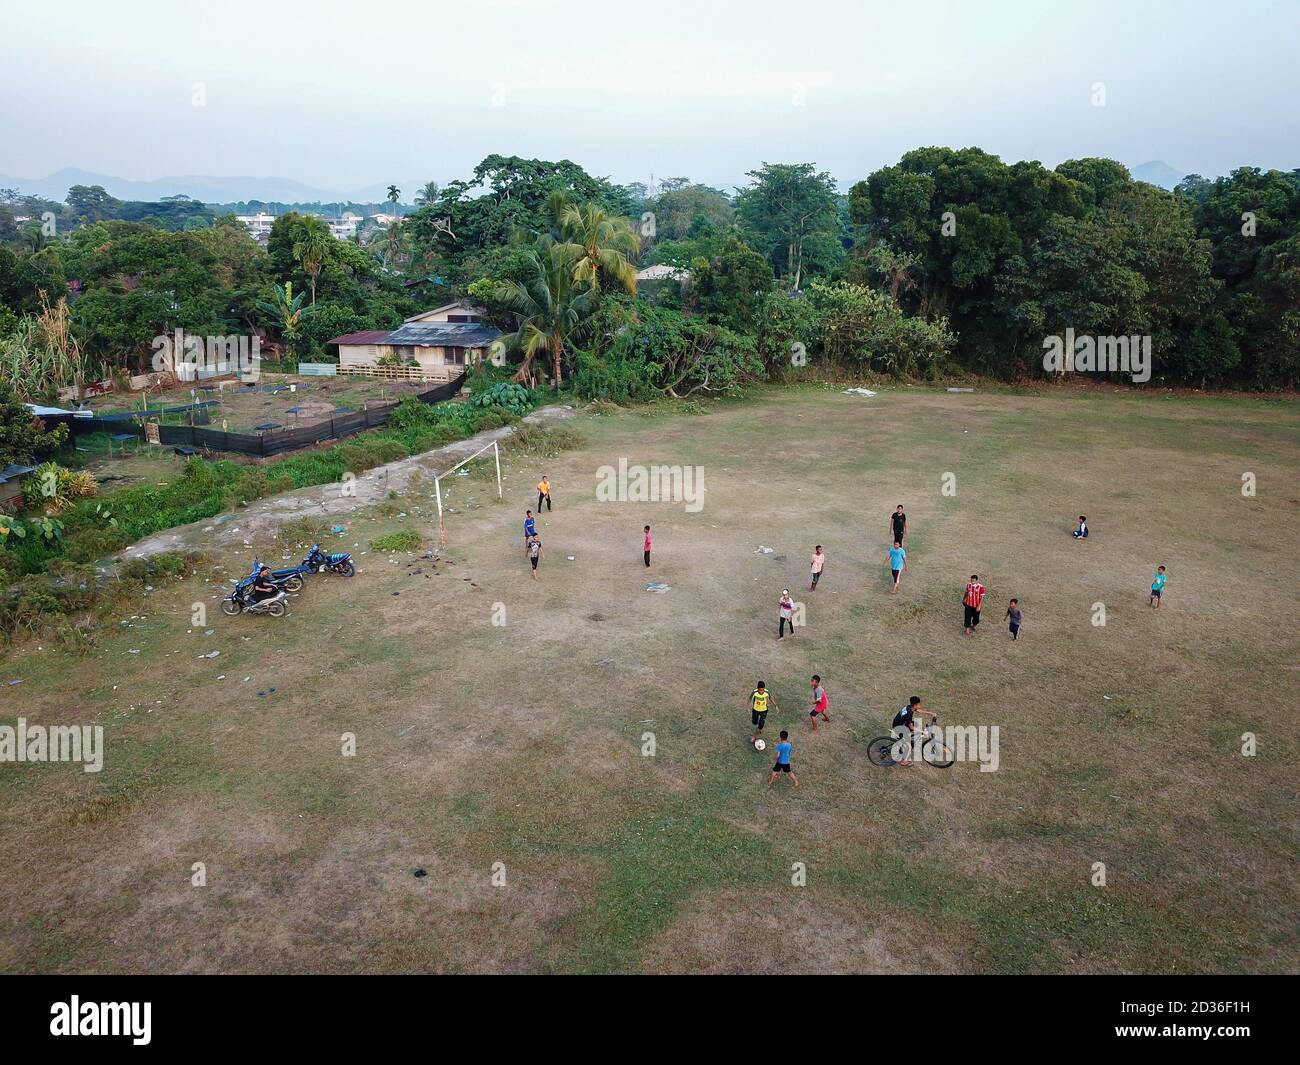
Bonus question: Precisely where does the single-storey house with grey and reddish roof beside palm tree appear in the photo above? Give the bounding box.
[329,300,506,380]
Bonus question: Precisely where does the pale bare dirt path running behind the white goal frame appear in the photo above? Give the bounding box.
[122,406,577,558]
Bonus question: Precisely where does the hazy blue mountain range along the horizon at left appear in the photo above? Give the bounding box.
[0,166,423,203]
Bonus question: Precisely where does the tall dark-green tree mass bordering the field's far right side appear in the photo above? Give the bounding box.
[849,148,1300,389]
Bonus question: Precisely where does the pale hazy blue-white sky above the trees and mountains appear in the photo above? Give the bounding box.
[0,0,1300,198]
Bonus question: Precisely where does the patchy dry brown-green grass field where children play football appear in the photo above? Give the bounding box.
[0,389,1300,973]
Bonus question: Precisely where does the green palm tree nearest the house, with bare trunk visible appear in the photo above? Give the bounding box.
[497,238,595,388]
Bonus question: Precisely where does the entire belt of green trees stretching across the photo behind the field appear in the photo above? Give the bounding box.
[0,148,1300,395]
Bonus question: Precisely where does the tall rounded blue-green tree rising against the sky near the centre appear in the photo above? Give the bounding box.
[736,163,844,291]
